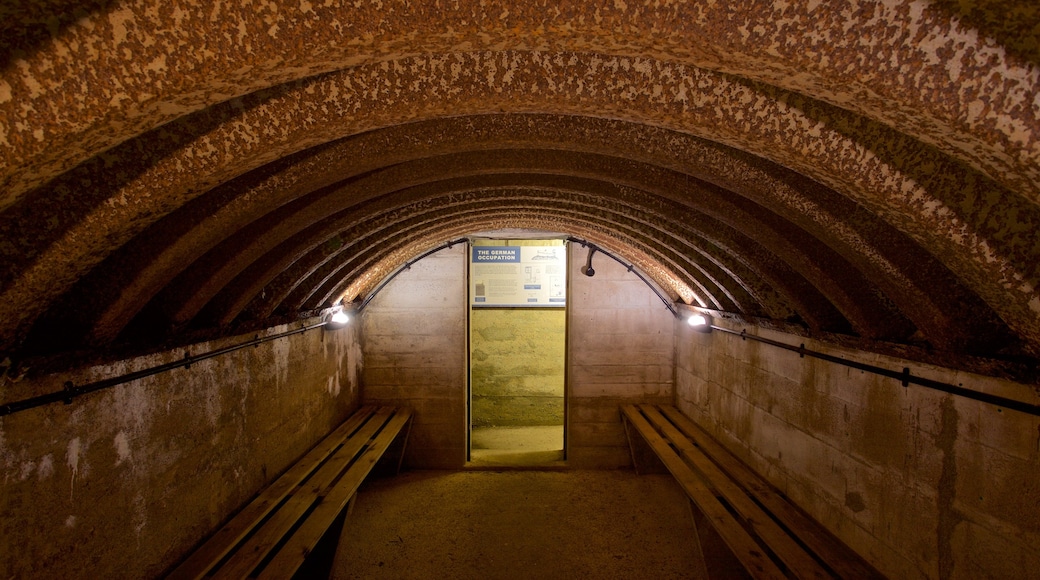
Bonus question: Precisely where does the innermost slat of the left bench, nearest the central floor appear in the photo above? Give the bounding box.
[258,411,412,580]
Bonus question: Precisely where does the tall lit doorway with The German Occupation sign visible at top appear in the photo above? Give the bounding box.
[469,239,567,466]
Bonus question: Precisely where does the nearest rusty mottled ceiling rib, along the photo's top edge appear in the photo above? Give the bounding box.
[0,0,1038,205]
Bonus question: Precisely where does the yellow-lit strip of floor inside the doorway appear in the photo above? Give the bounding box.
[470,425,564,467]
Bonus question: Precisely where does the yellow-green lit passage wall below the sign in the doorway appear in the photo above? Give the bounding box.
[470,308,567,427]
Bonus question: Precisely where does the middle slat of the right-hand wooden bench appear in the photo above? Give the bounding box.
[640,405,832,579]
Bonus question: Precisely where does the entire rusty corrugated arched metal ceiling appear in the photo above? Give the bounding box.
[0,0,1040,378]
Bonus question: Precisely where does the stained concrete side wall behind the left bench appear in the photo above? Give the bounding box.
[0,320,361,578]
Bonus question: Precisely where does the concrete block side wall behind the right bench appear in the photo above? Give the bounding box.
[676,321,1040,578]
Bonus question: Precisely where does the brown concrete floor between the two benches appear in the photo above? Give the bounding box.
[333,470,700,580]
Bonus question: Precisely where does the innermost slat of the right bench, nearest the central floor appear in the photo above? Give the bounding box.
[622,405,784,579]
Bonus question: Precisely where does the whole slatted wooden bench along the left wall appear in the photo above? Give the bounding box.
[168,406,412,579]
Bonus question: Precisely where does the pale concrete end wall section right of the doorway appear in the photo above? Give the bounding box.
[567,244,675,468]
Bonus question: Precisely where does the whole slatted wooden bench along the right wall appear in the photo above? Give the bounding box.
[621,404,884,579]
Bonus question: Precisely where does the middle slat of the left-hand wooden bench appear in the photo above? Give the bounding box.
[214,407,393,579]
